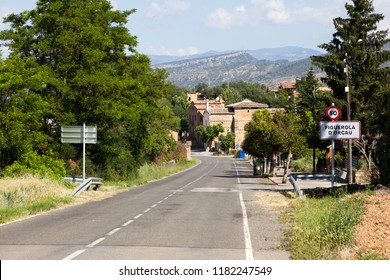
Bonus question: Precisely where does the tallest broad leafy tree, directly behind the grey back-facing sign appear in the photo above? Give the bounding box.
[0,0,177,177]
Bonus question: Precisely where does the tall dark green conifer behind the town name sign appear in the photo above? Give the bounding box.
[312,0,390,183]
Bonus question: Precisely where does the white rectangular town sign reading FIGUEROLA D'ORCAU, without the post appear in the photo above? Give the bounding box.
[320,121,360,140]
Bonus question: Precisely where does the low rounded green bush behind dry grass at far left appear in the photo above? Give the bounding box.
[4,151,66,179]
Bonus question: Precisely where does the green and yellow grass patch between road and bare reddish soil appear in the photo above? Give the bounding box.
[286,193,365,260]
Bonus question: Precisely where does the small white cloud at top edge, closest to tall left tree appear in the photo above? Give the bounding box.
[146,0,190,18]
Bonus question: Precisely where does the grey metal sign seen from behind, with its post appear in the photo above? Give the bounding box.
[61,124,97,182]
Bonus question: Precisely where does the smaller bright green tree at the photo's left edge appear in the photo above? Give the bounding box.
[0,55,53,168]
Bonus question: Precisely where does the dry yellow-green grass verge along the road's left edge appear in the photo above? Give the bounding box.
[0,160,197,224]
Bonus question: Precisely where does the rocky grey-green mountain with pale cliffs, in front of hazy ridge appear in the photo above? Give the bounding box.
[154,51,320,88]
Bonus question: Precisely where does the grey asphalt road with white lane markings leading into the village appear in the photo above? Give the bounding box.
[0,156,289,260]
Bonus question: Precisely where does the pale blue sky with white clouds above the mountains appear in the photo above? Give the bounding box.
[0,0,390,55]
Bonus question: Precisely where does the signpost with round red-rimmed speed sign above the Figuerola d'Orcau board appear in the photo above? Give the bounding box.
[320,105,360,187]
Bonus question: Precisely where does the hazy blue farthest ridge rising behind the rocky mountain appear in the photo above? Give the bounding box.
[148,47,321,65]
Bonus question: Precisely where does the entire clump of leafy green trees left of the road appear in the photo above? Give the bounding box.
[0,0,180,178]
